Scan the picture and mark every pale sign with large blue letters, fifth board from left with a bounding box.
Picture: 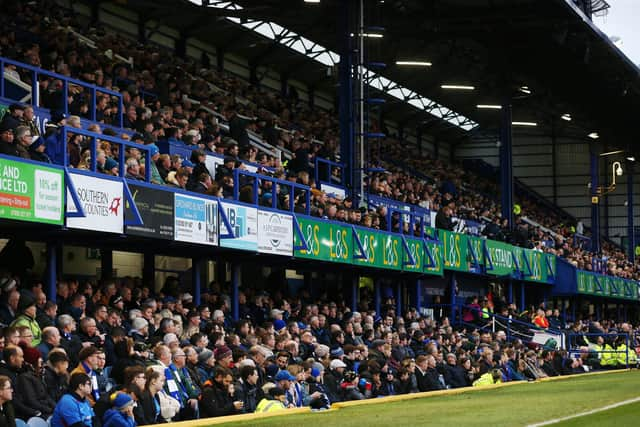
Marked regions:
[220,202,258,252]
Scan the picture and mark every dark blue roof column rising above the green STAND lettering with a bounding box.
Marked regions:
[500,98,513,230]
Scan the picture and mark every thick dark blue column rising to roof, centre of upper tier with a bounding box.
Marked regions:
[338,1,357,189]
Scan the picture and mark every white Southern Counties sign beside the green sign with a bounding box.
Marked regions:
[67,172,124,233]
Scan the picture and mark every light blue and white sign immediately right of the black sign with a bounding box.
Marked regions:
[174,193,218,245]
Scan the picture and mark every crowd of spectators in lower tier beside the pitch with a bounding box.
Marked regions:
[0,274,640,427]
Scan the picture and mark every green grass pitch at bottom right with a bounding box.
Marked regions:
[219,370,640,427]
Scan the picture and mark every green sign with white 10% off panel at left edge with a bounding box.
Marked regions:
[0,159,64,225]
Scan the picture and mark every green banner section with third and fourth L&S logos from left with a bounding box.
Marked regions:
[353,227,403,270]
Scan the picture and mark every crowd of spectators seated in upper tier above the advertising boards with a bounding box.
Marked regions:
[0,0,640,279]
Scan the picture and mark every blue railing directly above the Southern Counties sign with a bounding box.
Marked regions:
[61,126,151,182]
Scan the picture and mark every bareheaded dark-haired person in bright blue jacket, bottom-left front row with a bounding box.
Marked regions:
[51,373,94,427]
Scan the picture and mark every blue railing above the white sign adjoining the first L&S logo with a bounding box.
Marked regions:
[233,169,311,215]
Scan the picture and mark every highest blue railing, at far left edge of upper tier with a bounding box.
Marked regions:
[0,57,123,128]
